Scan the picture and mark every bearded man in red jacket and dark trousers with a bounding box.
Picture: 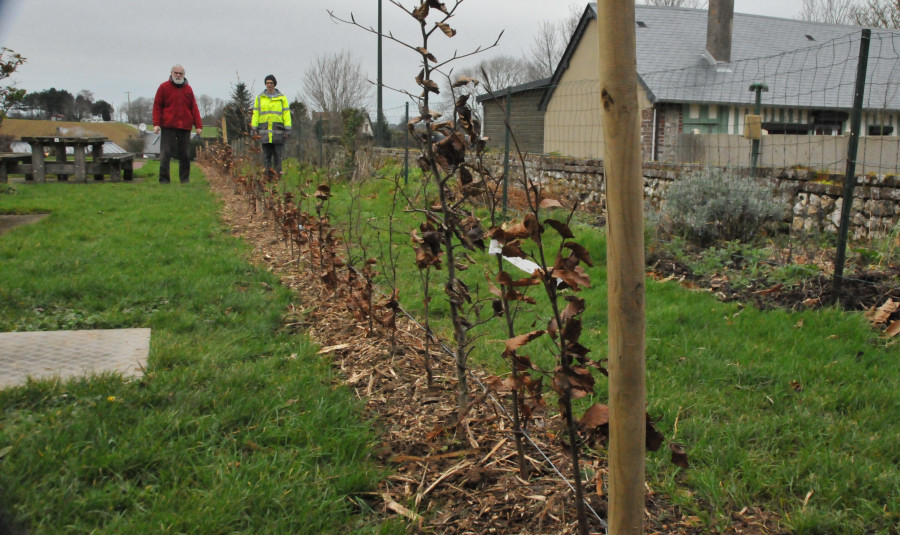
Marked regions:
[153,65,203,184]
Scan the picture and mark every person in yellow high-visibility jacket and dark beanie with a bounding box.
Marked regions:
[250,74,291,173]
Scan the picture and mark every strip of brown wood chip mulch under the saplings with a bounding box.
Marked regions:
[204,166,787,535]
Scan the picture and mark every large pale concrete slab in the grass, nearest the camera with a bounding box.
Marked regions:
[0,329,150,389]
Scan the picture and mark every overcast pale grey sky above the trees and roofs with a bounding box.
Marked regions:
[0,0,802,117]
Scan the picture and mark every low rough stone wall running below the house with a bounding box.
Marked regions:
[375,149,900,241]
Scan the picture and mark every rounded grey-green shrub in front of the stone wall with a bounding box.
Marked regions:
[659,169,785,244]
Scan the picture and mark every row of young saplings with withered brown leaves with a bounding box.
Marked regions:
[205,0,687,533]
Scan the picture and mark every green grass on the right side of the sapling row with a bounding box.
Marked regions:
[296,163,900,534]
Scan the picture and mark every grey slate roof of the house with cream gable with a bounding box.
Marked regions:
[540,3,900,110]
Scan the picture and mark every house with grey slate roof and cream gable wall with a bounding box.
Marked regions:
[524,0,900,160]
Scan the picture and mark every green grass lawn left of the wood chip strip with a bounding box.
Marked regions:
[0,162,402,534]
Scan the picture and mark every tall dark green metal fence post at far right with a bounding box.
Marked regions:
[832,28,872,303]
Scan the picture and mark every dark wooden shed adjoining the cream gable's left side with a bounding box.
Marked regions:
[475,78,550,154]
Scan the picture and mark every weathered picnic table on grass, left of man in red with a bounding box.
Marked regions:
[22,136,108,182]
